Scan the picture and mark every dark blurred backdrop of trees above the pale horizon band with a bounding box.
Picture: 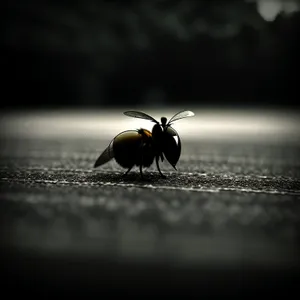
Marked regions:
[2,0,300,107]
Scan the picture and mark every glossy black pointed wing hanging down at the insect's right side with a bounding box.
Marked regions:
[162,127,181,170]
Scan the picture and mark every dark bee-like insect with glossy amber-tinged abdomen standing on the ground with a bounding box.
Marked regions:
[94,110,195,178]
